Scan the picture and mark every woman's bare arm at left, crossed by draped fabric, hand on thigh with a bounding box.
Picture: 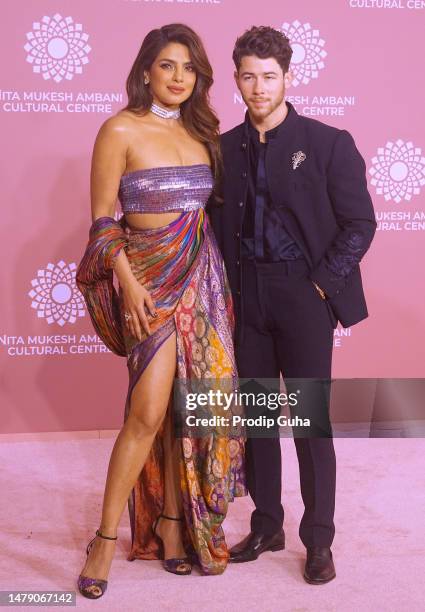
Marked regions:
[90,117,155,340]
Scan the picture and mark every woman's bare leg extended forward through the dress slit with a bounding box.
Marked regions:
[81,332,176,588]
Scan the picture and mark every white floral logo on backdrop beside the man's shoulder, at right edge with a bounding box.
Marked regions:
[369,140,425,204]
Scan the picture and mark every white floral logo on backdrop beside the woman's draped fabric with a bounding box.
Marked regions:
[28,261,86,327]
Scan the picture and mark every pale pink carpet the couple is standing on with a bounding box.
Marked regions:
[0,437,425,612]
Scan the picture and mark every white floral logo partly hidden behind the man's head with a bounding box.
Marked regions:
[280,20,327,87]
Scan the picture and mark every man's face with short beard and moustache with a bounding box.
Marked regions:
[235,55,291,121]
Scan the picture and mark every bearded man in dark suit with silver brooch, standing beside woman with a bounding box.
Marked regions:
[209,27,376,584]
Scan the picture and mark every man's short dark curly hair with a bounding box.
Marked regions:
[232,26,292,74]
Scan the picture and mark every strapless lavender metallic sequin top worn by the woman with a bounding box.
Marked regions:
[118,164,214,214]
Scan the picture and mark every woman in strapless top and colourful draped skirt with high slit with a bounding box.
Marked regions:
[77,24,247,598]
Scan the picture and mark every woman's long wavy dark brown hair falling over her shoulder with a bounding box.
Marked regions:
[124,23,222,194]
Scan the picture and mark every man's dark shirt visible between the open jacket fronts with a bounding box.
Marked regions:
[242,109,303,263]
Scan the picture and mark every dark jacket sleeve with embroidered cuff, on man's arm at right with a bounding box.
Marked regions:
[310,130,376,298]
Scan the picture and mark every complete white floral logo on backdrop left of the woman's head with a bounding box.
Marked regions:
[24,13,91,83]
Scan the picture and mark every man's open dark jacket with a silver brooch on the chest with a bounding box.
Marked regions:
[207,102,376,342]
